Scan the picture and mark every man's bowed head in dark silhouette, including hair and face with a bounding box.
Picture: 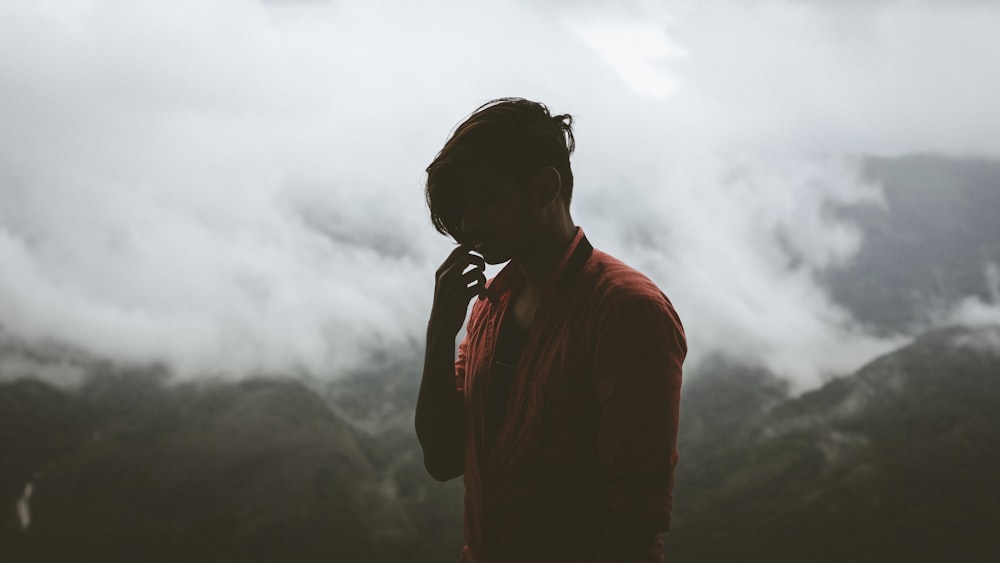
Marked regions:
[426,98,574,260]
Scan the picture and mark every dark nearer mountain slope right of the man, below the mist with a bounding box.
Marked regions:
[667,327,1000,563]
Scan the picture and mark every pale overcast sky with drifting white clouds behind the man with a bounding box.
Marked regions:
[0,0,1000,387]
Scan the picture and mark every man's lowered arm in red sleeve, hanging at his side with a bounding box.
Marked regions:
[595,297,687,563]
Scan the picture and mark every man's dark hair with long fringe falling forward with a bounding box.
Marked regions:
[425,98,576,240]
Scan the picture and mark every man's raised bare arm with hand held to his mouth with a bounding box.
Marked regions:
[414,246,486,481]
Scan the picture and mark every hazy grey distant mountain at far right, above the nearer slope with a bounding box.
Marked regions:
[825,155,1000,333]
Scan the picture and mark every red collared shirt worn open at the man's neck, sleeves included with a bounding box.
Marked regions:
[455,229,687,563]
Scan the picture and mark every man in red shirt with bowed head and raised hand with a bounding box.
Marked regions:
[415,98,687,563]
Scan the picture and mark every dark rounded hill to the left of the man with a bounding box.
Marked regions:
[0,372,461,562]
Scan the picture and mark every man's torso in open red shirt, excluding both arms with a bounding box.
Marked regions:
[464,239,680,561]
